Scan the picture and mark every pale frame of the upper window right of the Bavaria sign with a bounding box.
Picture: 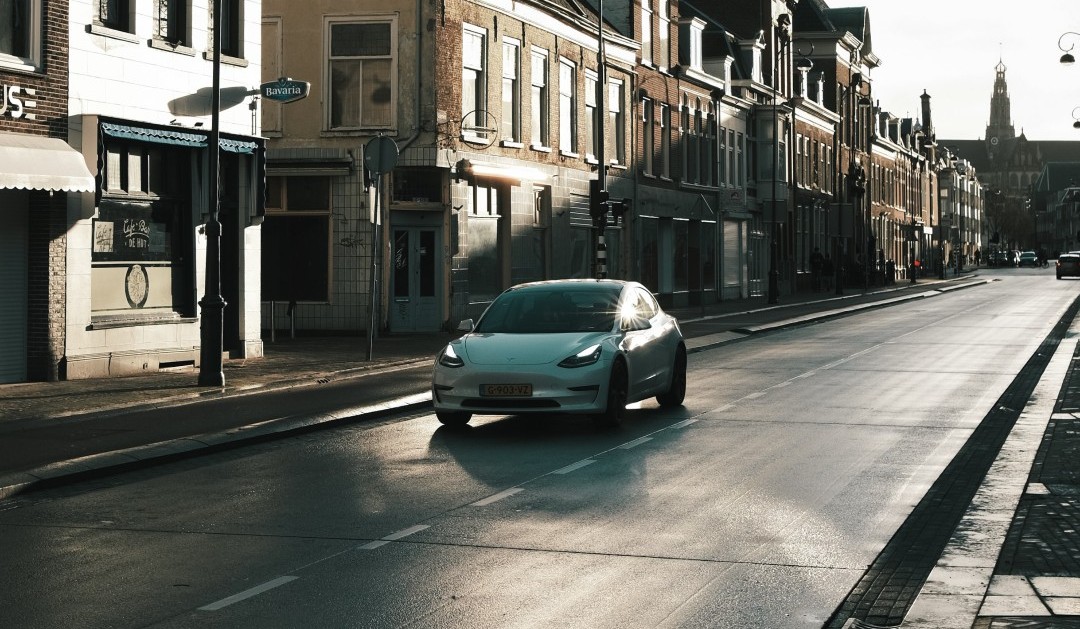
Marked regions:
[323,14,399,133]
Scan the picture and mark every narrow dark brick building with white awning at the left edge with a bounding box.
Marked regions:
[0,0,94,383]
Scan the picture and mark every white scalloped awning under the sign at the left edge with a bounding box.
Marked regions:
[0,132,95,192]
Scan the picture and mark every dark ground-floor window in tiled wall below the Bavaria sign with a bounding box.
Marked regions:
[262,176,333,302]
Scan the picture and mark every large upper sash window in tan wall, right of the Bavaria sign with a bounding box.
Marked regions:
[327,18,396,130]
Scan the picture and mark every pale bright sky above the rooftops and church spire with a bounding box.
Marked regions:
[826,0,1080,140]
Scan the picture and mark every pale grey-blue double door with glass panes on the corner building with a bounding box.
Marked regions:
[390,227,442,332]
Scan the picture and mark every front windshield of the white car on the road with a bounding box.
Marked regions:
[474,285,619,334]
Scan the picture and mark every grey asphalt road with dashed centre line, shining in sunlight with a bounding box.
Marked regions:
[0,271,1075,629]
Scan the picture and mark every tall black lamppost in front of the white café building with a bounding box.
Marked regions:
[199,0,225,387]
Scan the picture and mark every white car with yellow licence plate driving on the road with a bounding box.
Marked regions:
[431,280,686,426]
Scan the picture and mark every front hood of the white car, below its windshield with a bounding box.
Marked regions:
[461,332,608,365]
